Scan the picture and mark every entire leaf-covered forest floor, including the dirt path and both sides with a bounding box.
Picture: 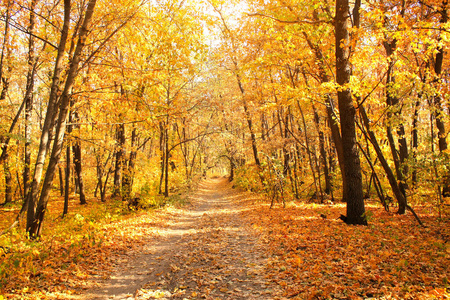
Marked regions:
[0,178,450,300]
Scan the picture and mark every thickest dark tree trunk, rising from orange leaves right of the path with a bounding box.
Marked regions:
[335,0,367,225]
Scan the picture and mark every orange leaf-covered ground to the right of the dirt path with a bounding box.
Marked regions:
[245,199,450,299]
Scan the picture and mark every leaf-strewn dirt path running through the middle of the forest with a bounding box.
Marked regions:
[84,178,282,300]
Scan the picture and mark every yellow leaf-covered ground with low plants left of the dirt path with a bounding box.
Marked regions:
[0,193,174,299]
